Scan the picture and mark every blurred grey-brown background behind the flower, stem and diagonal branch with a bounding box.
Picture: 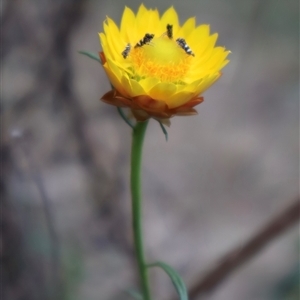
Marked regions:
[0,0,299,300]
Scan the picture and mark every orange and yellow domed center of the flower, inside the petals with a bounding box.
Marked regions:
[130,36,193,83]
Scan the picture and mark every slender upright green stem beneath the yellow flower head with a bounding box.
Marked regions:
[130,121,151,300]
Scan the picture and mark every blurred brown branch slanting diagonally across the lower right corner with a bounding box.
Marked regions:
[189,197,300,299]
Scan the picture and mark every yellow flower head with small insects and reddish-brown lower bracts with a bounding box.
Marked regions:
[99,4,230,121]
